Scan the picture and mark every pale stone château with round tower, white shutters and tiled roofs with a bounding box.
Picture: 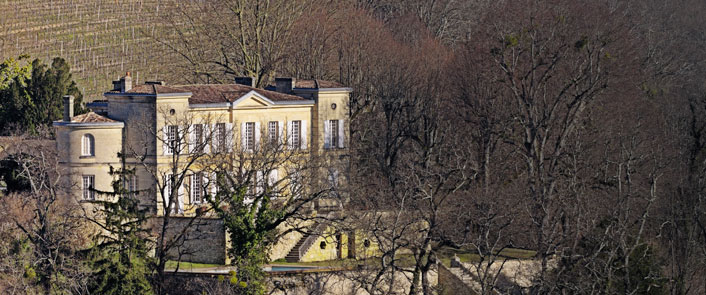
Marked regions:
[54,73,352,262]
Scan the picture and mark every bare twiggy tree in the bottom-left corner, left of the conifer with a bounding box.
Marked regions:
[2,135,90,293]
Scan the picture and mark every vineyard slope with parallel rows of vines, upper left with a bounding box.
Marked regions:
[0,0,182,101]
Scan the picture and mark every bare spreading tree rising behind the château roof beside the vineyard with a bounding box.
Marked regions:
[160,0,312,87]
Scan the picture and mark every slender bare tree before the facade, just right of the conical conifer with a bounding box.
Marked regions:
[125,108,221,293]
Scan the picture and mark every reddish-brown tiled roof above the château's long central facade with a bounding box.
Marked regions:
[109,84,308,104]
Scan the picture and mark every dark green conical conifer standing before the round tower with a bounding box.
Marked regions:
[90,153,152,294]
